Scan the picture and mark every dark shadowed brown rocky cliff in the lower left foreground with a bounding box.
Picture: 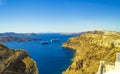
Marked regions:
[0,44,38,74]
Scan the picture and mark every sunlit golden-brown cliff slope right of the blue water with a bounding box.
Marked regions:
[63,31,120,74]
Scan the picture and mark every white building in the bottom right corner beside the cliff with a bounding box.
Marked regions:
[96,53,120,74]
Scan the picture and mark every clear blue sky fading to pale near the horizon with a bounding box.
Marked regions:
[0,0,120,33]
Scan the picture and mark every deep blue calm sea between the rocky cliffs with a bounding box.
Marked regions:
[4,34,75,74]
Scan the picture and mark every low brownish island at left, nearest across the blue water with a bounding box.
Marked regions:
[0,36,39,42]
